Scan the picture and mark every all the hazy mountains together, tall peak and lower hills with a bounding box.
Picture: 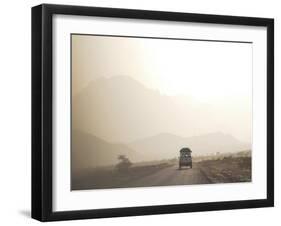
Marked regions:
[72,76,250,168]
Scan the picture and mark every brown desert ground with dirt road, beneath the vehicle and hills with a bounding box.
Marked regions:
[71,152,251,190]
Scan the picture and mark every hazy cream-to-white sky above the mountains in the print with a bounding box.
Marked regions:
[72,35,252,141]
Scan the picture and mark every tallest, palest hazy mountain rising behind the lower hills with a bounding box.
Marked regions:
[72,76,243,143]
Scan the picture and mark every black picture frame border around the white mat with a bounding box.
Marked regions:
[32,4,274,221]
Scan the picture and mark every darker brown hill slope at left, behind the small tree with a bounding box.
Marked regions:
[71,131,141,170]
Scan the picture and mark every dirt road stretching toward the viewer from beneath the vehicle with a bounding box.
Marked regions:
[126,164,210,187]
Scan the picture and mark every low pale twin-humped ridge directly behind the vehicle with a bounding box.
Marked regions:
[128,132,248,159]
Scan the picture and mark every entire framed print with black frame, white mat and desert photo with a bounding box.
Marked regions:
[32,4,274,221]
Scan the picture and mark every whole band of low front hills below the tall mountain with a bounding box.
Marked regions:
[71,131,248,169]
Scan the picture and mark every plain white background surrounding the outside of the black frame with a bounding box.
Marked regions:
[0,0,276,226]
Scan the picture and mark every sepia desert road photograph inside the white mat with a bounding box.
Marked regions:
[70,33,253,191]
